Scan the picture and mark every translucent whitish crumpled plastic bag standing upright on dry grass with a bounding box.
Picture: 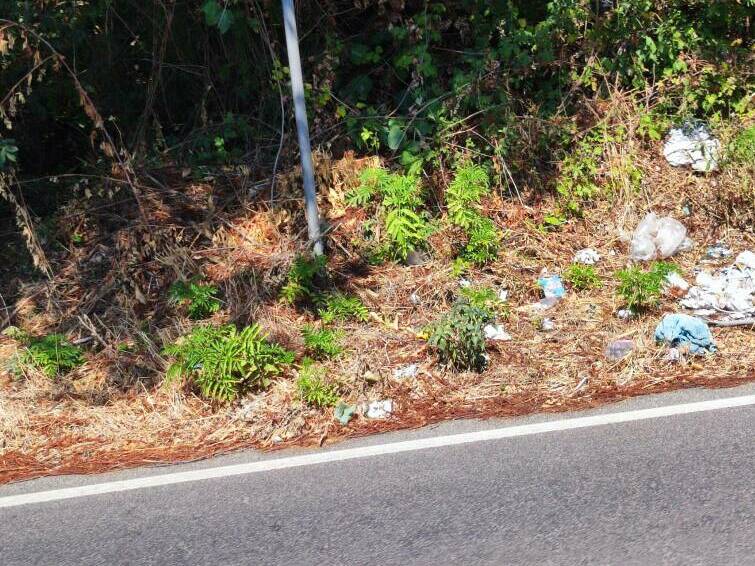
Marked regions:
[629,212,693,261]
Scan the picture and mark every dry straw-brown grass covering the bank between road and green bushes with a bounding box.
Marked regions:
[0,120,755,482]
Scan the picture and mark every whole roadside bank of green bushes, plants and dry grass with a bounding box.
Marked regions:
[0,0,755,481]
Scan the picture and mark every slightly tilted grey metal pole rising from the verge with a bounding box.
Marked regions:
[281,0,322,255]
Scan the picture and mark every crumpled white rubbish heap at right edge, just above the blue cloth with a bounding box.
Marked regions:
[680,255,755,326]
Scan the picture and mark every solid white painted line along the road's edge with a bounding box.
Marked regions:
[0,395,755,508]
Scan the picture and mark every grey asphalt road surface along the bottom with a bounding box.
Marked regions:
[0,387,755,566]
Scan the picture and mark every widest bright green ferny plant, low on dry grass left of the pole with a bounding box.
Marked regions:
[164,324,294,401]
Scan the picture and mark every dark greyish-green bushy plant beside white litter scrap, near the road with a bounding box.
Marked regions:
[428,301,493,371]
